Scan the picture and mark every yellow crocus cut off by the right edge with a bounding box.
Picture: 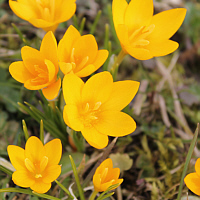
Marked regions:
[184,158,200,196]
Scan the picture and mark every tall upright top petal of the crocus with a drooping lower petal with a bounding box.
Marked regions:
[40,31,58,73]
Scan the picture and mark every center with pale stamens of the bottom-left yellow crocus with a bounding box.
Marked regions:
[24,156,48,179]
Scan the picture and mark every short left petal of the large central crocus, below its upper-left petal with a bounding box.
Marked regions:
[63,105,84,131]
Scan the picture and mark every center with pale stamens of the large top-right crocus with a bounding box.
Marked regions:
[129,24,155,48]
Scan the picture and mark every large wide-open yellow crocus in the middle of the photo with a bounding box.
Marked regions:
[63,72,139,149]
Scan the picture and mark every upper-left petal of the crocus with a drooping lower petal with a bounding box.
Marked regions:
[21,46,45,76]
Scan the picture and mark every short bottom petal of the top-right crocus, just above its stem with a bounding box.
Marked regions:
[125,46,153,60]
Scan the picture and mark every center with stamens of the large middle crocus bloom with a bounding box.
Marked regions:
[81,101,101,127]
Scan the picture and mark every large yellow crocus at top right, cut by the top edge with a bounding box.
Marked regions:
[112,0,186,60]
